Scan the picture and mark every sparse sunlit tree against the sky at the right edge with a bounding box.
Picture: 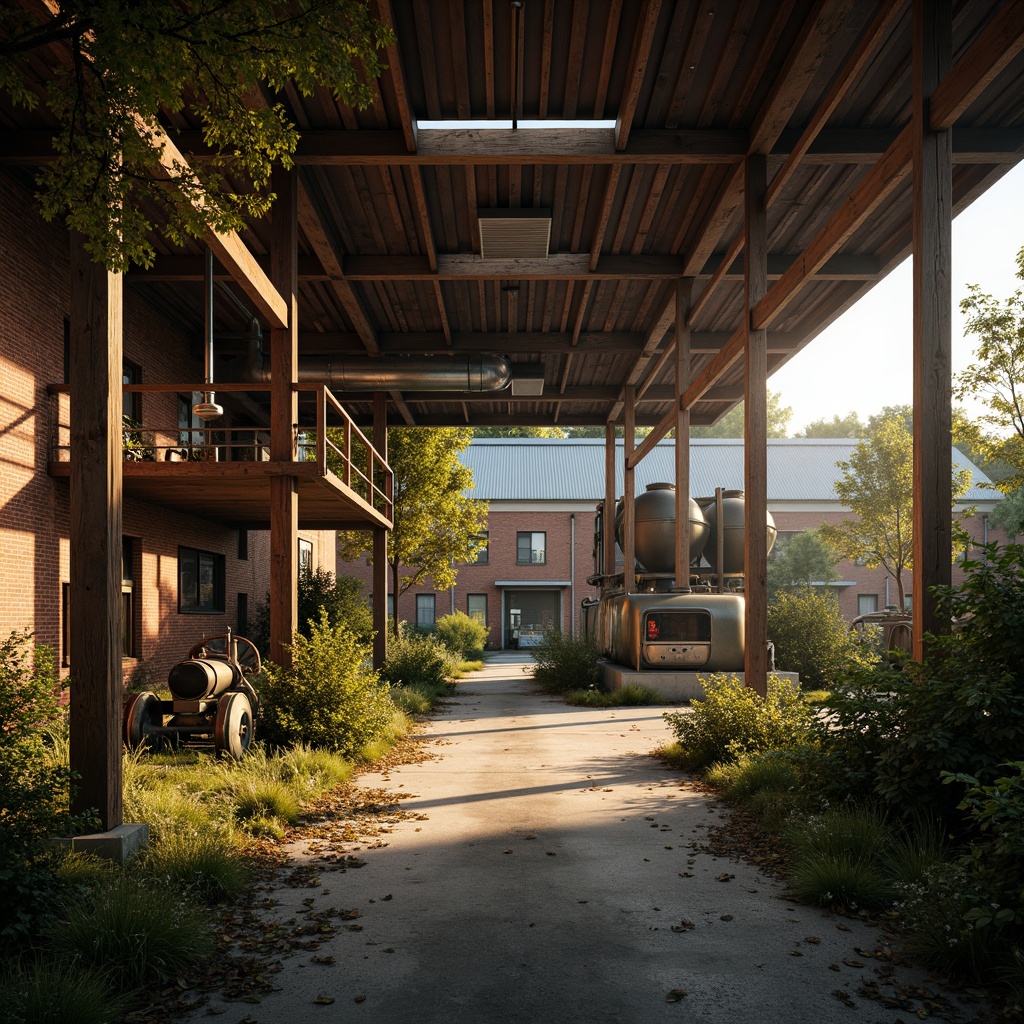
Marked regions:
[953,249,1024,494]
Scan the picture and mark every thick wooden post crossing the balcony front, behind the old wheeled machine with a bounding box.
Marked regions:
[270,170,299,668]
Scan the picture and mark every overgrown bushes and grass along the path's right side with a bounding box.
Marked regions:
[666,546,1024,1002]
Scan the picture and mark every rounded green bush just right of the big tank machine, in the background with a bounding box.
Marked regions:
[768,587,879,688]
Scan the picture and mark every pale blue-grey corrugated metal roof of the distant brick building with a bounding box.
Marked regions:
[462,437,998,503]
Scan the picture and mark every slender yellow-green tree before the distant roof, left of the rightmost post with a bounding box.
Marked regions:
[819,416,970,608]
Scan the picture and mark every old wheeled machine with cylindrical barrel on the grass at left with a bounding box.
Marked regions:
[122,630,260,760]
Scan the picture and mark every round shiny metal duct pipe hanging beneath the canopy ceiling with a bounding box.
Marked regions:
[243,339,512,392]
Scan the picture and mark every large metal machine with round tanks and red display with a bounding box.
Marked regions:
[582,483,776,672]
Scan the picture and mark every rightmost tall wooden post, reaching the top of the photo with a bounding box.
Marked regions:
[912,0,952,660]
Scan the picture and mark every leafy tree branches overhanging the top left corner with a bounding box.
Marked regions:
[0,0,393,270]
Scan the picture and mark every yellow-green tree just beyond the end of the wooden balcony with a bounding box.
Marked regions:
[338,427,487,635]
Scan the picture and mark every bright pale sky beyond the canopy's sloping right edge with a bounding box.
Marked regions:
[768,157,1024,434]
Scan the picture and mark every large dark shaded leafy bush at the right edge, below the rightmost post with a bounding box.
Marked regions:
[818,545,1024,827]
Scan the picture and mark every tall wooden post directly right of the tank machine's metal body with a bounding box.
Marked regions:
[743,154,768,696]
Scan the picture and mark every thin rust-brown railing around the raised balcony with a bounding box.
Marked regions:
[47,383,394,520]
